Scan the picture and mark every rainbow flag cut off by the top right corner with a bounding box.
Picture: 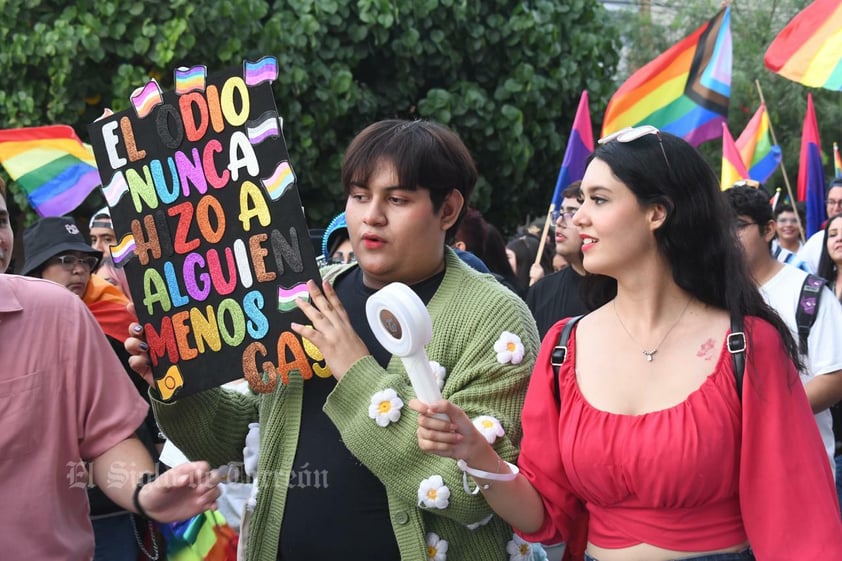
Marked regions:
[763,0,842,91]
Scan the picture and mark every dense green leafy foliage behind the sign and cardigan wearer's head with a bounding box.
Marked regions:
[0,0,620,236]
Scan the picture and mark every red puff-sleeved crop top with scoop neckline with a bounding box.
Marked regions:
[518,317,842,561]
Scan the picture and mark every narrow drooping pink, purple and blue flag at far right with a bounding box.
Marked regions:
[798,93,827,237]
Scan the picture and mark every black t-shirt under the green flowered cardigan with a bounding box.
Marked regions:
[278,267,444,561]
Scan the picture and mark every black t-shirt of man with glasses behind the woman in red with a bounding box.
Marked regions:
[526,267,588,339]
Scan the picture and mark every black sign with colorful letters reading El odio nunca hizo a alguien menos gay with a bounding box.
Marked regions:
[89,57,330,401]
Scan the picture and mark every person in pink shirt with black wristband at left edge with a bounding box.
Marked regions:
[0,181,219,561]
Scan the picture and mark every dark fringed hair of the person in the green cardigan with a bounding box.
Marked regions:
[342,119,477,239]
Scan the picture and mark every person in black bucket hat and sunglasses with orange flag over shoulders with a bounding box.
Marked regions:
[21,216,169,561]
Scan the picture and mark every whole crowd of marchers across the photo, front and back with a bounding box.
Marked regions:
[0,120,842,561]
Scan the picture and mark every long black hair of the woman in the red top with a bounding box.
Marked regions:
[583,132,803,370]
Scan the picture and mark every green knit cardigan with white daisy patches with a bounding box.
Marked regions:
[150,249,539,561]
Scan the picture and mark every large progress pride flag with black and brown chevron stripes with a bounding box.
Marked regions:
[602,7,731,146]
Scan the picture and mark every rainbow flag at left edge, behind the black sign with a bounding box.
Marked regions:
[0,125,100,216]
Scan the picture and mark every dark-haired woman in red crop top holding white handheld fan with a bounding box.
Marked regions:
[410,126,842,561]
